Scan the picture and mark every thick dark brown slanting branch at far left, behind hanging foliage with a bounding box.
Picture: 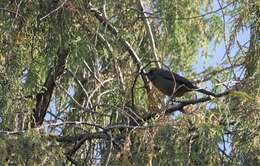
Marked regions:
[32,49,68,127]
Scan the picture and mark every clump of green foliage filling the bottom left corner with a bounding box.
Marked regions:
[0,131,64,165]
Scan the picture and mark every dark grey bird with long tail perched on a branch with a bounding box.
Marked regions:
[144,68,216,97]
